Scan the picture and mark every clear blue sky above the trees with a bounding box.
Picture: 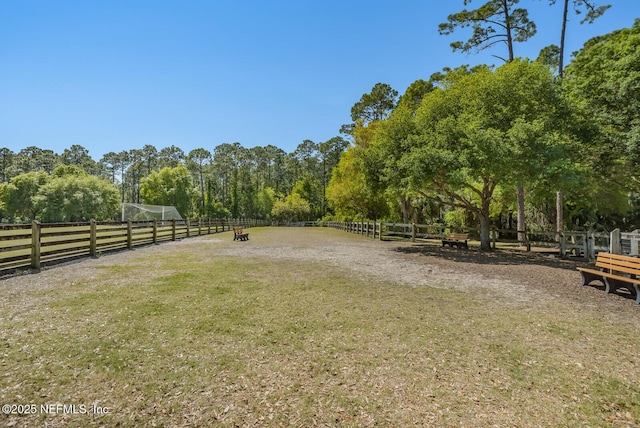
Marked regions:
[0,0,640,160]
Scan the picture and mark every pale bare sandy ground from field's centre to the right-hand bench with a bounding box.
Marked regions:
[221,228,640,317]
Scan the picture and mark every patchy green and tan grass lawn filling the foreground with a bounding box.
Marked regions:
[0,229,640,427]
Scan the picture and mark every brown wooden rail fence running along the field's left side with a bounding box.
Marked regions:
[0,219,266,273]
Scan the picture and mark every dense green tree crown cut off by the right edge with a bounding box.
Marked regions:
[563,22,640,186]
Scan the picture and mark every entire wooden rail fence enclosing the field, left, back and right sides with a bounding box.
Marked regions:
[0,219,640,274]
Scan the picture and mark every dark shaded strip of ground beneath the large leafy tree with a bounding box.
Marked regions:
[394,243,587,271]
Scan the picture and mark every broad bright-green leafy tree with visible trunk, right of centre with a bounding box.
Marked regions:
[396,60,564,249]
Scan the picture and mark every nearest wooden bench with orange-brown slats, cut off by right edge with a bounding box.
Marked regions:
[577,253,640,305]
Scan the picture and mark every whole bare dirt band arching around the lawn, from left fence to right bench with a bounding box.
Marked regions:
[0,228,640,324]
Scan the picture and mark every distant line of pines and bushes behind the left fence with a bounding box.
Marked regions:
[0,136,348,223]
